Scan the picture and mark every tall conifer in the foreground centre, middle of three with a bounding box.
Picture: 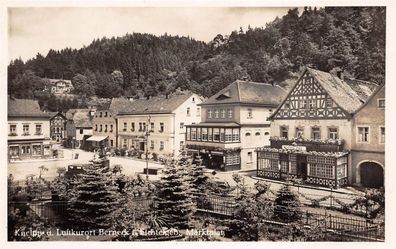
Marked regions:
[155,155,194,229]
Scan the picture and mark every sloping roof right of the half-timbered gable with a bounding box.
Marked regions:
[303,67,365,114]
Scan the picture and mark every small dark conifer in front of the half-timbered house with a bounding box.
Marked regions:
[274,184,302,223]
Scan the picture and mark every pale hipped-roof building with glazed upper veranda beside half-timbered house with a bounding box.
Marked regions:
[186,80,286,170]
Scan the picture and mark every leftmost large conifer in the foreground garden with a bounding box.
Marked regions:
[69,159,118,229]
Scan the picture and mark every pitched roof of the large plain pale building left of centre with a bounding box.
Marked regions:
[119,93,193,115]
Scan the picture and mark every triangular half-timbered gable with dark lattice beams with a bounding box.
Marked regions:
[271,70,350,119]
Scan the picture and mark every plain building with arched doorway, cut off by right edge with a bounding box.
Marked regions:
[351,85,385,187]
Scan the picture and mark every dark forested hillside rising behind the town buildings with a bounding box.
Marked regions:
[8,7,386,103]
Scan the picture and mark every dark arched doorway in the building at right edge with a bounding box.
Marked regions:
[360,162,384,188]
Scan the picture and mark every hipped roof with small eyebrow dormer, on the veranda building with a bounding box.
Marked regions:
[200,80,286,106]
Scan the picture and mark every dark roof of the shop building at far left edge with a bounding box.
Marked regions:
[8,98,50,119]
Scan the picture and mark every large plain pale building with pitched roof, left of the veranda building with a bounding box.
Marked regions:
[117,93,202,158]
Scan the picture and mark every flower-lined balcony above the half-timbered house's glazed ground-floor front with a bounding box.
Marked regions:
[270,137,344,152]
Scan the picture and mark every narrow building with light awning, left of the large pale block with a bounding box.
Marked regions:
[87,98,131,147]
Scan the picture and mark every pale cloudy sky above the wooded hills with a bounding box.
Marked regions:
[8,7,289,61]
